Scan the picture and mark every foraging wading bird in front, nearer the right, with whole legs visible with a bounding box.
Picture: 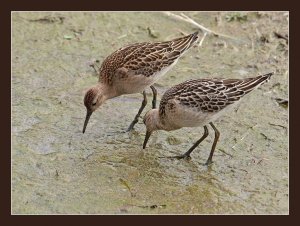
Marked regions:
[143,72,273,165]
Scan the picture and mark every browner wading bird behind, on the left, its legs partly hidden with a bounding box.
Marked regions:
[82,32,199,133]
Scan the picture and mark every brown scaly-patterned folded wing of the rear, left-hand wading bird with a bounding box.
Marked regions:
[99,32,199,83]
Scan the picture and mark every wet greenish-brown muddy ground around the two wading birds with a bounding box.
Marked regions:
[11,12,289,214]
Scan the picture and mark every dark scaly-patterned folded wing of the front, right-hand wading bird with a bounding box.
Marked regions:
[161,73,273,113]
